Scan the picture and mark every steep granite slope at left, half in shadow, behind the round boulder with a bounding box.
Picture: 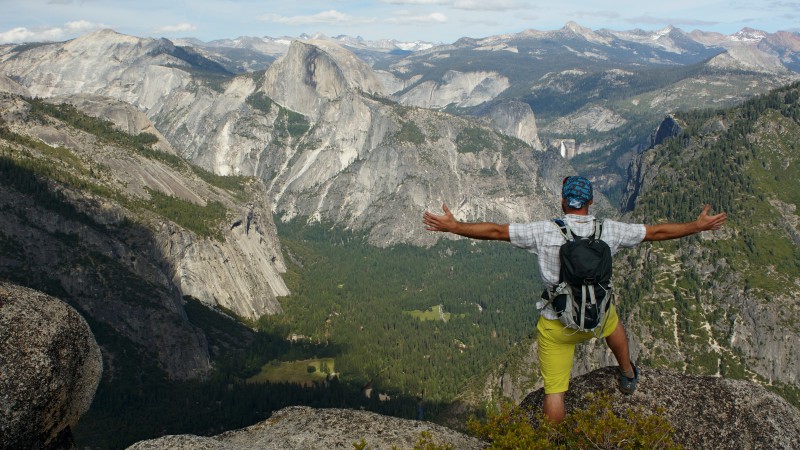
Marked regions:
[0,94,288,378]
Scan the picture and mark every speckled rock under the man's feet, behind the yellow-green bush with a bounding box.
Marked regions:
[522,367,800,449]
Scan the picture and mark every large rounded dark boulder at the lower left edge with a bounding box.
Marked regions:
[0,283,103,449]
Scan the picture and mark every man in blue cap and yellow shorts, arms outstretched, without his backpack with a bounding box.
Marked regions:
[422,176,726,423]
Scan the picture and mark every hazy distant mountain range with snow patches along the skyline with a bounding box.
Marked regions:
[173,22,800,72]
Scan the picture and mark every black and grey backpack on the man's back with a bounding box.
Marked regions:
[545,219,612,334]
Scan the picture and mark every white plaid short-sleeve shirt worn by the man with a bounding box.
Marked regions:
[508,214,645,319]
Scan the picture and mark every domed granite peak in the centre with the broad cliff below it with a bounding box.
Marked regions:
[256,39,567,245]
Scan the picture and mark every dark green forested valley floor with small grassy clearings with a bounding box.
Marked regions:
[75,221,539,448]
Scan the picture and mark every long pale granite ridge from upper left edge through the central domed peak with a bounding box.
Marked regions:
[0,31,570,245]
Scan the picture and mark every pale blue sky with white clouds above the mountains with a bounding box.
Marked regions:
[0,0,800,43]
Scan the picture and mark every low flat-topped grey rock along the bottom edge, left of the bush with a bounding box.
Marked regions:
[128,406,487,450]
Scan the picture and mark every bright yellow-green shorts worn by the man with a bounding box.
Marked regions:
[536,305,619,394]
